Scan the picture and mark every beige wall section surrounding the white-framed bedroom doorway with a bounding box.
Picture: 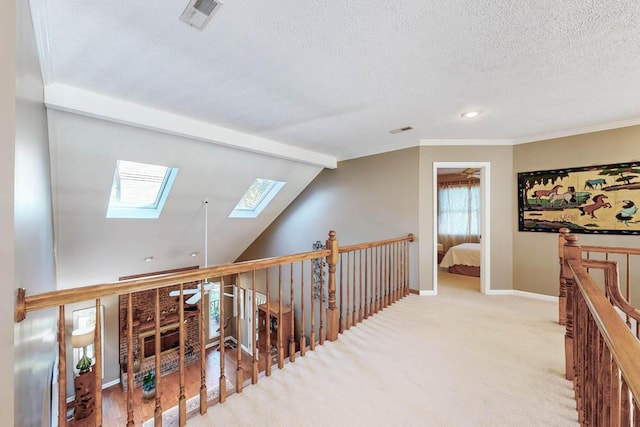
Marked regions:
[418,146,516,290]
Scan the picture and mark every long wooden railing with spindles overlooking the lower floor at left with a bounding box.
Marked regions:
[16,231,414,426]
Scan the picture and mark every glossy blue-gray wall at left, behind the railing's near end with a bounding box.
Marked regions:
[12,1,57,426]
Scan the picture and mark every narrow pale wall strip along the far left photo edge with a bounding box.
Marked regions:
[0,0,16,426]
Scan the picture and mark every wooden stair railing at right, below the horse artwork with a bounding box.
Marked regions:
[560,233,640,426]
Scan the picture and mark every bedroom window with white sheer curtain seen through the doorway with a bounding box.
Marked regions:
[438,182,480,251]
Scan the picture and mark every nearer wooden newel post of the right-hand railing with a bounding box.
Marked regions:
[561,234,582,380]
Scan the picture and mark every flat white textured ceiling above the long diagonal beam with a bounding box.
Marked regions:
[38,0,640,159]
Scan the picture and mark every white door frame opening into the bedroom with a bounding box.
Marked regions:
[433,162,491,295]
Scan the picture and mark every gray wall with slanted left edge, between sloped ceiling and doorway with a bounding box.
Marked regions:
[239,148,419,289]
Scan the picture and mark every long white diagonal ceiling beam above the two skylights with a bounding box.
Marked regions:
[44,83,338,169]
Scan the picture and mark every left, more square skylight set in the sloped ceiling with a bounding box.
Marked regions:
[107,160,178,218]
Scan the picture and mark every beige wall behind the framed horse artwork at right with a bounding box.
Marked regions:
[511,126,640,296]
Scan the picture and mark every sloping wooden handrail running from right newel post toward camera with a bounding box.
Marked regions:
[568,260,640,399]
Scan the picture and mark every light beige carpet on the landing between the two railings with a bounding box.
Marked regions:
[188,274,577,427]
